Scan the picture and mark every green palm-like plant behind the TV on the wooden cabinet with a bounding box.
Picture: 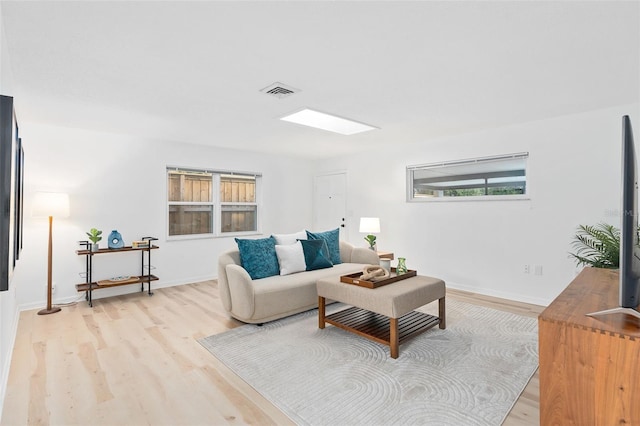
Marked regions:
[569,223,620,269]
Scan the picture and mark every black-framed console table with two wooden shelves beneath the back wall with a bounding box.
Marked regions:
[76,237,160,306]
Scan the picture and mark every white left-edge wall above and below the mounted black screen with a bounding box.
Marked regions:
[0,5,18,418]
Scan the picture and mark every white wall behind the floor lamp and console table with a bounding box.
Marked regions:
[15,123,312,309]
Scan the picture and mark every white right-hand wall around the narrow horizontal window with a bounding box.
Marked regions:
[316,104,640,305]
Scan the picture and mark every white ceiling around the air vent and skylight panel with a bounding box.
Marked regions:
[0,0,640,158]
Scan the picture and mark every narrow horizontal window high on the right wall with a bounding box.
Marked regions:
[407,153,529,201]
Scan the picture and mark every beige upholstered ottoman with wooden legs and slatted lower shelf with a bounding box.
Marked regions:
[316,276,446,358]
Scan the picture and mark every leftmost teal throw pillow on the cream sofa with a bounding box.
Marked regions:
[236,237,280,280]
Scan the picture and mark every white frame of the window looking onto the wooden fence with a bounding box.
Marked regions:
[165,166,262,241]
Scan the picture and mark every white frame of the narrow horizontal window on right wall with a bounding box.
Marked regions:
[406,152,530,203]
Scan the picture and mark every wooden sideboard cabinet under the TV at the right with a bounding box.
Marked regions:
[538,268,640,426]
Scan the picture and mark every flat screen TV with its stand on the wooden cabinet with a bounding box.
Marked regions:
[588,115,640,318]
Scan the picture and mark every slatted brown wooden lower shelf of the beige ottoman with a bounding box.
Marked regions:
[321,307,440,358]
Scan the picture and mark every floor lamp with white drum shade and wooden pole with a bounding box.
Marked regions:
[31,192,69,315]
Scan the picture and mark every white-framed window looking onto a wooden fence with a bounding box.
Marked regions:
[167,167,260,237]
